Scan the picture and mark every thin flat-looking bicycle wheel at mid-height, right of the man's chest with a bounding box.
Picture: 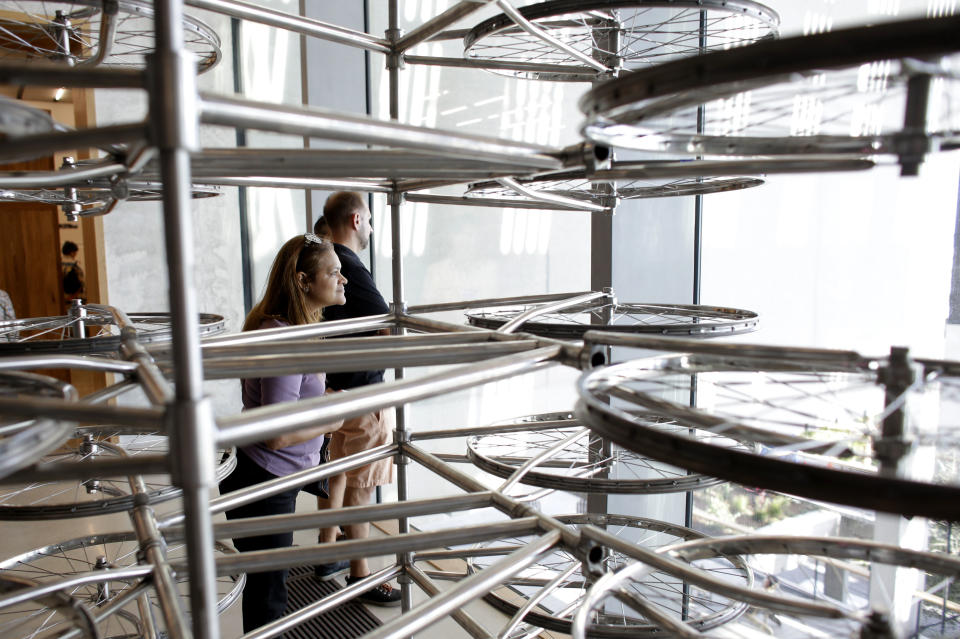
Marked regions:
[467,298,760,339]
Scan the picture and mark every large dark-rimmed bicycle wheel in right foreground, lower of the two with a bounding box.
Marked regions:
[576,337,960,520]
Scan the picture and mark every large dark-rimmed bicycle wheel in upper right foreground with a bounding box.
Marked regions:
[580,16,960,163]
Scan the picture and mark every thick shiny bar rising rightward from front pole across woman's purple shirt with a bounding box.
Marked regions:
[218,346,563,446]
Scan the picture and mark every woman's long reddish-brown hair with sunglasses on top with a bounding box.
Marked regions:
[243,235,333,331]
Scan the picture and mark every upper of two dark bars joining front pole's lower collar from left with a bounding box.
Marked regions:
[0,397,166,430]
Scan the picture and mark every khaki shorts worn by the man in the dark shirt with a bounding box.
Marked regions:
[330,408,396,487]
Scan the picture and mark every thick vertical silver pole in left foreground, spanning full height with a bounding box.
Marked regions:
[150,0,220,639]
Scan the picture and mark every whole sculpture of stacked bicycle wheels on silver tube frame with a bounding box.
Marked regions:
[0,0,960,639]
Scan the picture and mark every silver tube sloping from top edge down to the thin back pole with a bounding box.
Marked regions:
[184,0,390,53]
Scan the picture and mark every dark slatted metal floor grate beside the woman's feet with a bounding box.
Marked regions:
[283,566,380,639]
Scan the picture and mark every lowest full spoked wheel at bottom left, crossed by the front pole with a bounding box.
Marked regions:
[0,532,245,639]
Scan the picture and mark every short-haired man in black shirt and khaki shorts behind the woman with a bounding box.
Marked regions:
[314,191,400,606]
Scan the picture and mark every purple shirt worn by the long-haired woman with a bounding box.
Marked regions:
[240,319,326,477]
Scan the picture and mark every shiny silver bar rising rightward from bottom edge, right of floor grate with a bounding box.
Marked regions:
[366,520,560,639]
